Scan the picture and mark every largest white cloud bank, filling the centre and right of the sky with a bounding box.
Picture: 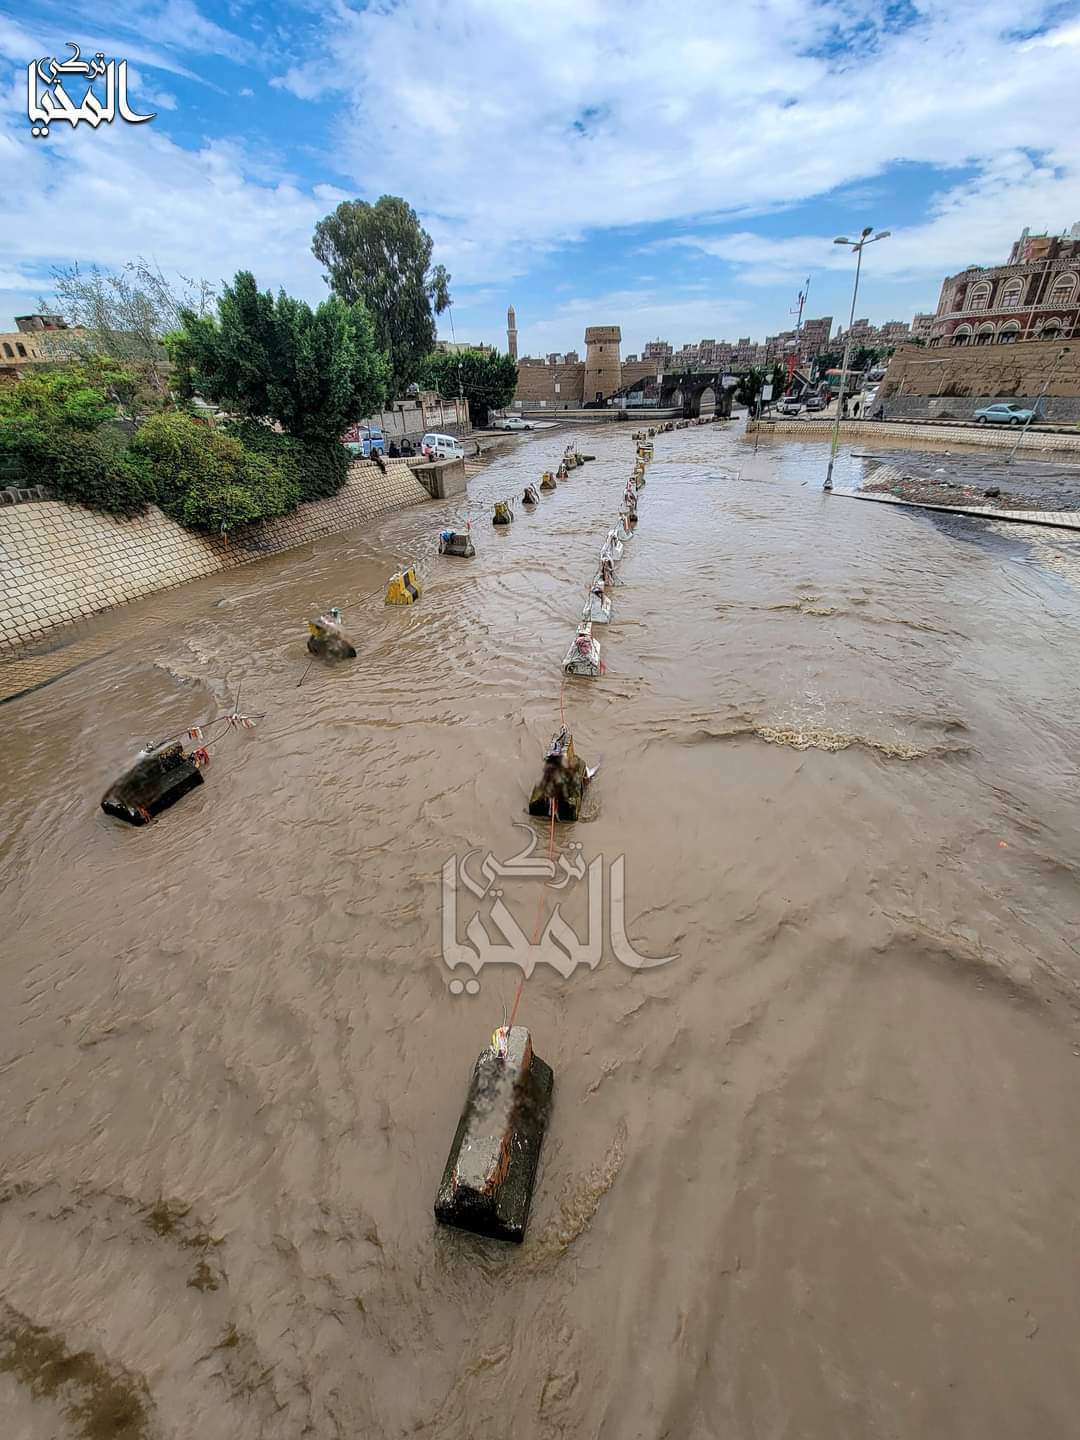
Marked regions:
[264,0,1080,279]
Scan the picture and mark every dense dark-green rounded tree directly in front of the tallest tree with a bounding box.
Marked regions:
[167,271,387,444]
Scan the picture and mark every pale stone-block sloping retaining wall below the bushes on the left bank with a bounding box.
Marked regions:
[0,459,429,654]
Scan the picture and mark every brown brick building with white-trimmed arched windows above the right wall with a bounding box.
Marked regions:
[929,223,1080,347]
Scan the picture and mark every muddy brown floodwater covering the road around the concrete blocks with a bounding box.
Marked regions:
[0,426,1080,1440]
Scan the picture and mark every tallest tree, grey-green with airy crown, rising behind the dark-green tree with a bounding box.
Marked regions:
[311,194,449,395]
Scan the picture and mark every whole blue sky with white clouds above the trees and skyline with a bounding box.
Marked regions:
[0,0,1080,354]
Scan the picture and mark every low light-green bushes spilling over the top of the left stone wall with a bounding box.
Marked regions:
[0,363,348,534]
